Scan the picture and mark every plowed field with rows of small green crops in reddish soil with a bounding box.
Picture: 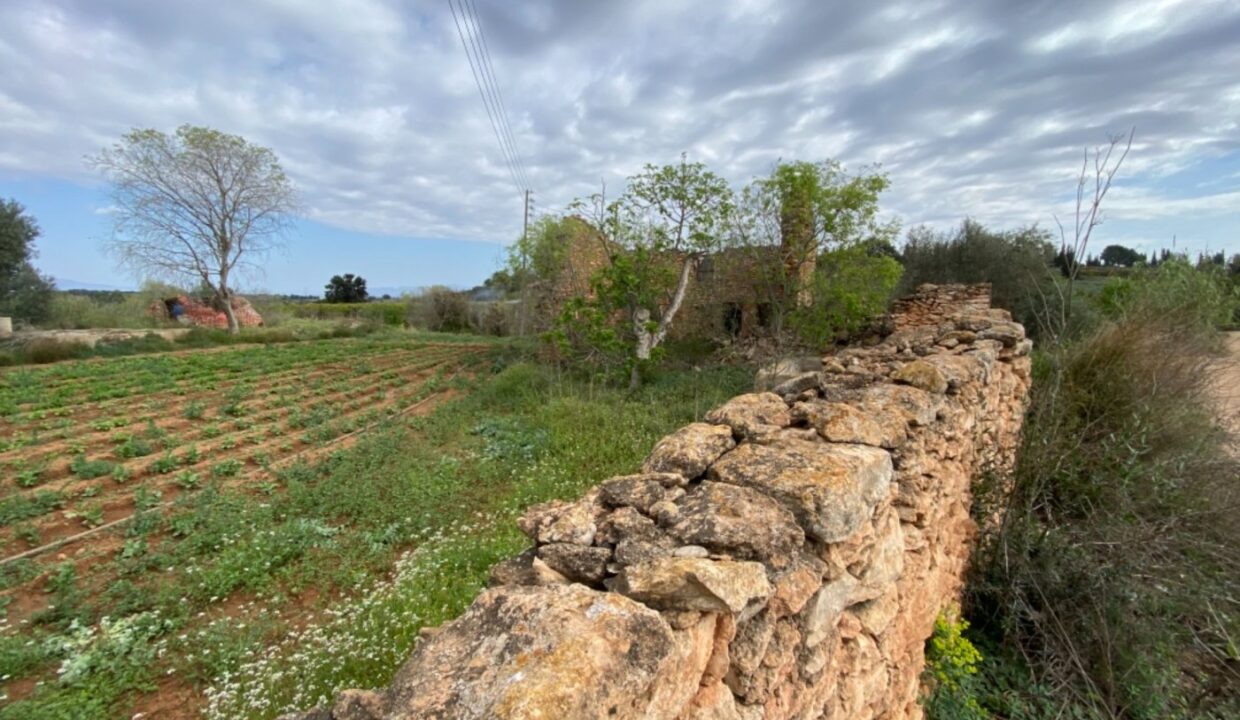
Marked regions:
[0,337,482,612]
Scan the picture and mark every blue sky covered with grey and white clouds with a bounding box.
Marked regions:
[0,0,1240,292]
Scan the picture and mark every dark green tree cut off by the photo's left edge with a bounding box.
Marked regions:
[0,194,53,322]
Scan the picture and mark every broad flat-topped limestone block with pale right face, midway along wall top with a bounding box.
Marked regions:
[711,441,893,543]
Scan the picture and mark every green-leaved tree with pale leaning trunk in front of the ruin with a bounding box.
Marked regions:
[559,156,733,387]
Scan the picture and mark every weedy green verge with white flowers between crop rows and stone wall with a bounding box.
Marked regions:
[0,356,749,720]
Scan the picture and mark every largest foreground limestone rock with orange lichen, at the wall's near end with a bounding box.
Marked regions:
[384,585,677,720]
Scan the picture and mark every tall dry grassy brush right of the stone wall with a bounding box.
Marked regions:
[968,261,1240,720]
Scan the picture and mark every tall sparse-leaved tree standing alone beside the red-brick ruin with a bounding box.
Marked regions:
[87,125,295,333]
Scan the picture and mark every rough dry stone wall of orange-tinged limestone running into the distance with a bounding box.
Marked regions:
[285,286,1030,720]
